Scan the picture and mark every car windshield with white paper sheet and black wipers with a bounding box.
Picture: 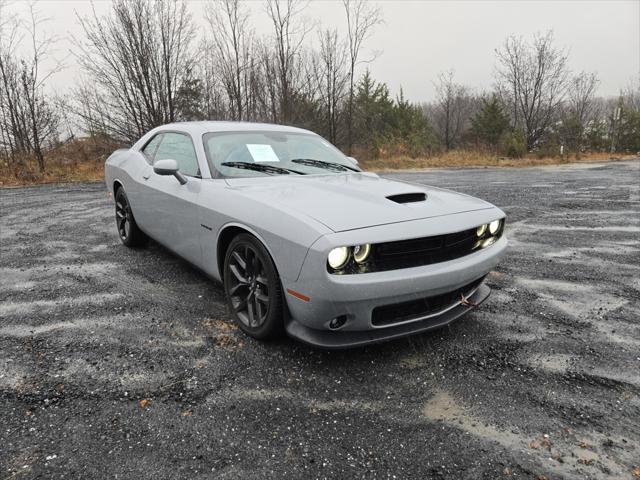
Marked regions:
[204,131,360,177]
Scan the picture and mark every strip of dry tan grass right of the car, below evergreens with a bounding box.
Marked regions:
[360,150,636,172]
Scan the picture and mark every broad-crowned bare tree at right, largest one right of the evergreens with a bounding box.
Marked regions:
[496,31,568,149]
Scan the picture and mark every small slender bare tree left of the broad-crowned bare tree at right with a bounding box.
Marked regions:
[432,70,472,150]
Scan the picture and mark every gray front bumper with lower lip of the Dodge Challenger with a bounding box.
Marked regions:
[284,229,507,348]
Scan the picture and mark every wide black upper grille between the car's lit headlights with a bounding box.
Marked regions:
[371,228,478,271]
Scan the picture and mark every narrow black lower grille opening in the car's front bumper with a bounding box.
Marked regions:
[371,277,484,327]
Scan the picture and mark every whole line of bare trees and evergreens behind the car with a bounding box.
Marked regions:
[0,0,640,171]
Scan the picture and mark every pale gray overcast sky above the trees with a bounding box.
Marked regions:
[14,0,640,102]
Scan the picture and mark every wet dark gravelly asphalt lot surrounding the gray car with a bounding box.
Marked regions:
[0,161,640,480]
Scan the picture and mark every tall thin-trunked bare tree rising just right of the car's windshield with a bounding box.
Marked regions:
[342,0,382,154]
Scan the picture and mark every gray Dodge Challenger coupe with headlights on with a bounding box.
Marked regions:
[105,122,507,348]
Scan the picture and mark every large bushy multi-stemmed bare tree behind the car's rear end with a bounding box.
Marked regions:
[76,0,194,141]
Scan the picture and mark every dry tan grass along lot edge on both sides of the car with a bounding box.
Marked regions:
[0,139,634,187]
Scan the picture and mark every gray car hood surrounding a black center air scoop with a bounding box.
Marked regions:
[226,173,494,232]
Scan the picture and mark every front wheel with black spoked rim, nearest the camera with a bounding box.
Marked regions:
[224,234,284,340]
